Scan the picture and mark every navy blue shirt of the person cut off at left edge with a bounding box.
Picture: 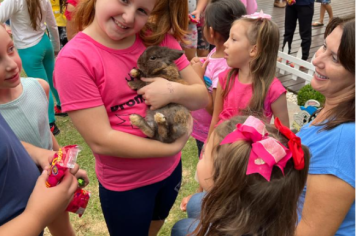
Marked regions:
[0,113,40,225]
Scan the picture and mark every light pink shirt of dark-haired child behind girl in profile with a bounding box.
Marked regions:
[192,48,229,142]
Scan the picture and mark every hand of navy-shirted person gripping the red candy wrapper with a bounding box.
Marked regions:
[24,171,78,227]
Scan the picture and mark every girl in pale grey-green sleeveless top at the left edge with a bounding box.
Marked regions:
[0,23,88,236]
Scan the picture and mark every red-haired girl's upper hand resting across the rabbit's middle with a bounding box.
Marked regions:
[137,77,176,110]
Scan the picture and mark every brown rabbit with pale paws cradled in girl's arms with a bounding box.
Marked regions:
[128,46,191,143]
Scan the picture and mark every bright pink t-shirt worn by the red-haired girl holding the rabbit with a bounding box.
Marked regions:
[53,32,189,191]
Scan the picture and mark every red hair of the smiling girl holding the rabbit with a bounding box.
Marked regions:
[74,0,188,46]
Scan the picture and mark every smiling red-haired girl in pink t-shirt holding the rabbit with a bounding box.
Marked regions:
[54,0,208,235]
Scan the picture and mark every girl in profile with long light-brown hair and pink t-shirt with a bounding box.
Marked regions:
[209,12,289,136]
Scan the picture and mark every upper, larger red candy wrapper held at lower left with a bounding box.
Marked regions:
[46,145,80,188]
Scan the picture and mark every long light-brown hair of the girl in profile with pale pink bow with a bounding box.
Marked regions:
[223,18,279,113]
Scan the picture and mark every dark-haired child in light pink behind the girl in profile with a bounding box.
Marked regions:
[191,0,246,157]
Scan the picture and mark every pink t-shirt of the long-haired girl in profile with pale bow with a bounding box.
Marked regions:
[218,70,286,124]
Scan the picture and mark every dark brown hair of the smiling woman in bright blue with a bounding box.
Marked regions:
[319,15,355,130]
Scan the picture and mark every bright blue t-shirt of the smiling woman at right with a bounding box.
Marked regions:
[297,123,355,236]
